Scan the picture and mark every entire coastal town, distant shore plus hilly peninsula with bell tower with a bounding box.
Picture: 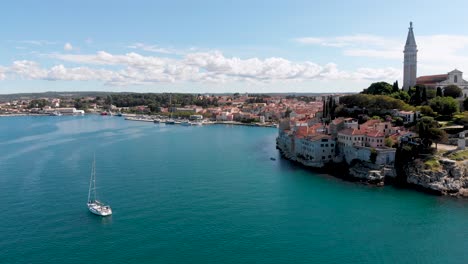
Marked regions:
[0,23,468,195]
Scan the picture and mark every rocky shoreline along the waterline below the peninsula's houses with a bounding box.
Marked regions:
[278,144,468,197]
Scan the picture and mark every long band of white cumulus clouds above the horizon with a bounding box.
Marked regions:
[1,51,399,85]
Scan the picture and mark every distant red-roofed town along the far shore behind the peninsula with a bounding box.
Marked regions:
[0,94,342,126]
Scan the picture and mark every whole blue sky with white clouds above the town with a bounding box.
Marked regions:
[0,1,468,93]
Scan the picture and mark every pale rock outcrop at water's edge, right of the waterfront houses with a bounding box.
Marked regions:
[404,158,468,196]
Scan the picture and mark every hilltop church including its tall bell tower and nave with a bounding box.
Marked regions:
[403,22,468,97]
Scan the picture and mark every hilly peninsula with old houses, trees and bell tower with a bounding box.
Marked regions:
[277,23,468,196]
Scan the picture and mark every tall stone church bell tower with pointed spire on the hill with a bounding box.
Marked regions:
[403,22,418,91]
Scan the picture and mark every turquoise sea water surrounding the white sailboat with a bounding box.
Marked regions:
[0,116,468,263]
